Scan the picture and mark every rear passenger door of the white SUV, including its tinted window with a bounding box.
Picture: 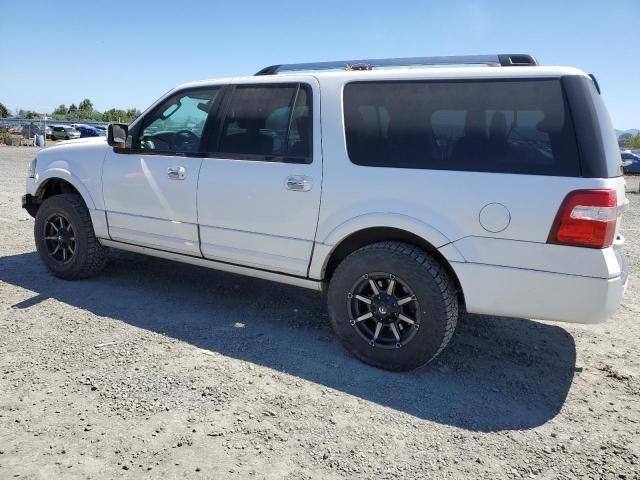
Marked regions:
[198,77,322,276]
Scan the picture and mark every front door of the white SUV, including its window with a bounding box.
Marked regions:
[102,87,219,256]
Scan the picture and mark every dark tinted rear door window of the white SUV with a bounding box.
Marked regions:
[219,85,312,160]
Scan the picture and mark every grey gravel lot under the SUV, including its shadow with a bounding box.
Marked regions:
[0,147,640,479]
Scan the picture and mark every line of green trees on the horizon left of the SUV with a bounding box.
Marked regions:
[0,98,140,123]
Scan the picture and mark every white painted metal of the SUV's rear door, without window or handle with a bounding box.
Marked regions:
[198,76,322,276]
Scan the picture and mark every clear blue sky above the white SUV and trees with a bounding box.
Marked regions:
[0,0,640,129]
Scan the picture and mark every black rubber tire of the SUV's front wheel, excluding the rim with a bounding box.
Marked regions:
[33,193,107,280]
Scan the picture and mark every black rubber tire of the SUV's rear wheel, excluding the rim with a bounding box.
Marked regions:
[327,241,458,371]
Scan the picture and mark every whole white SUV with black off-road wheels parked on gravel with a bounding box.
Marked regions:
[23,55,627,370]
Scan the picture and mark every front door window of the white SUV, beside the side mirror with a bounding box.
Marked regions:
[136,87,219,153]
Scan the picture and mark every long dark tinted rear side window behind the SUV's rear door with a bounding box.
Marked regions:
[344,80,580,176]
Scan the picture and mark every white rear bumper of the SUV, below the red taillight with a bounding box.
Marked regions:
[452,254,629,323]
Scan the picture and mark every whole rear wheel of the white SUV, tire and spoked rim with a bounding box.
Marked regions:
[328,242,458,371]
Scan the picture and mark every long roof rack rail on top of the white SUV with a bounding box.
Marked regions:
[256,54,538,75]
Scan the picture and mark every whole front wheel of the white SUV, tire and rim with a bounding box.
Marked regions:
[34,194,107,280]
